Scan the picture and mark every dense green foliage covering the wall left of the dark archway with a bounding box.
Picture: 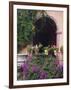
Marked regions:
[17,9,36,51]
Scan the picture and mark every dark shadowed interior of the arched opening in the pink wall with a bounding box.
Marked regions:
[33,16,57,46]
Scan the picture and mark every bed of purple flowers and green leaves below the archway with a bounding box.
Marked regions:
[17,54,63,80]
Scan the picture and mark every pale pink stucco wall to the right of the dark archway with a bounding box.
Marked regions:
[47,11,63,47]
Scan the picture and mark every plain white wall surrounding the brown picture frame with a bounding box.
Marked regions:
[0,0,71,90]
